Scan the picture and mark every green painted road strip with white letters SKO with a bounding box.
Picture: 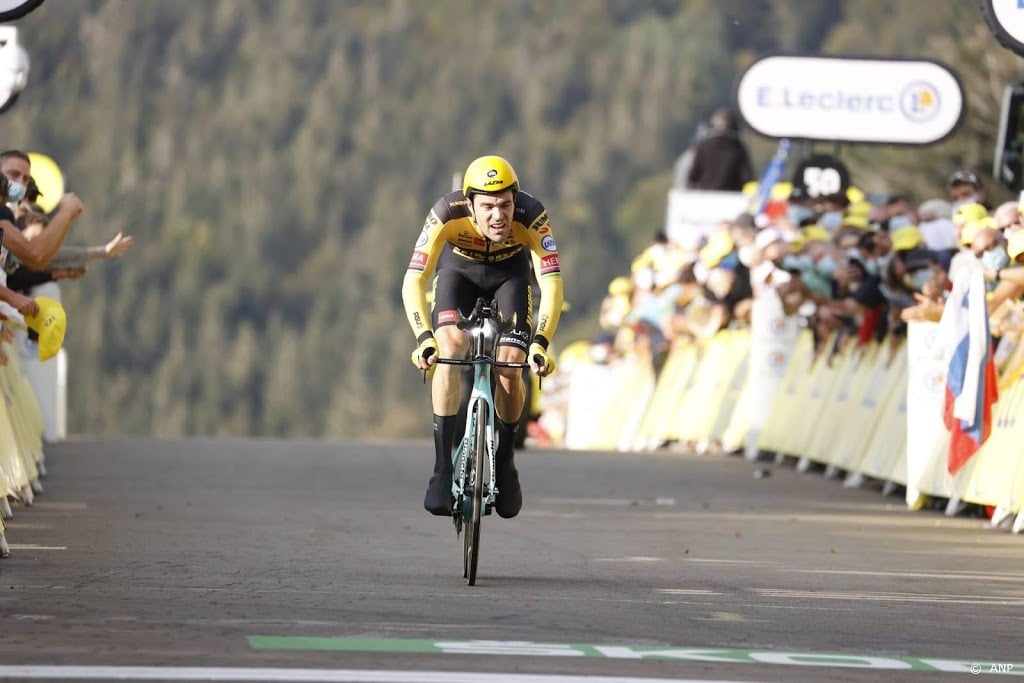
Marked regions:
[247,636,1024,676]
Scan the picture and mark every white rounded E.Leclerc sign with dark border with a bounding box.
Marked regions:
[736,55,964,144]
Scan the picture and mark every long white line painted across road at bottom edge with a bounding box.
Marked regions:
[0,665,750,683]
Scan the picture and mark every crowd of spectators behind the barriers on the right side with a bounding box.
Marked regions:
[585,171,1024,376]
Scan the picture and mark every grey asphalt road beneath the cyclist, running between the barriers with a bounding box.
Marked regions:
[0,438,1024,683]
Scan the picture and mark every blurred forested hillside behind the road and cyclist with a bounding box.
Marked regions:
[0,0,1024,438]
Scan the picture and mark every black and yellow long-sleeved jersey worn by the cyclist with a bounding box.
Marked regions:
[401,190,562,347]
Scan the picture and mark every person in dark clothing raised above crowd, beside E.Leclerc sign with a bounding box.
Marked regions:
[686,108,754,191]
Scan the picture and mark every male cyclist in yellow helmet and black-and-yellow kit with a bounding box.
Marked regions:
[401,156,562,518]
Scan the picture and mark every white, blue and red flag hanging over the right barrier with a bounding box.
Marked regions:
[939,267,998,474]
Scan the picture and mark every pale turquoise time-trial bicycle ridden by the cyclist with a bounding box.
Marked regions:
[428,297,529,586]
